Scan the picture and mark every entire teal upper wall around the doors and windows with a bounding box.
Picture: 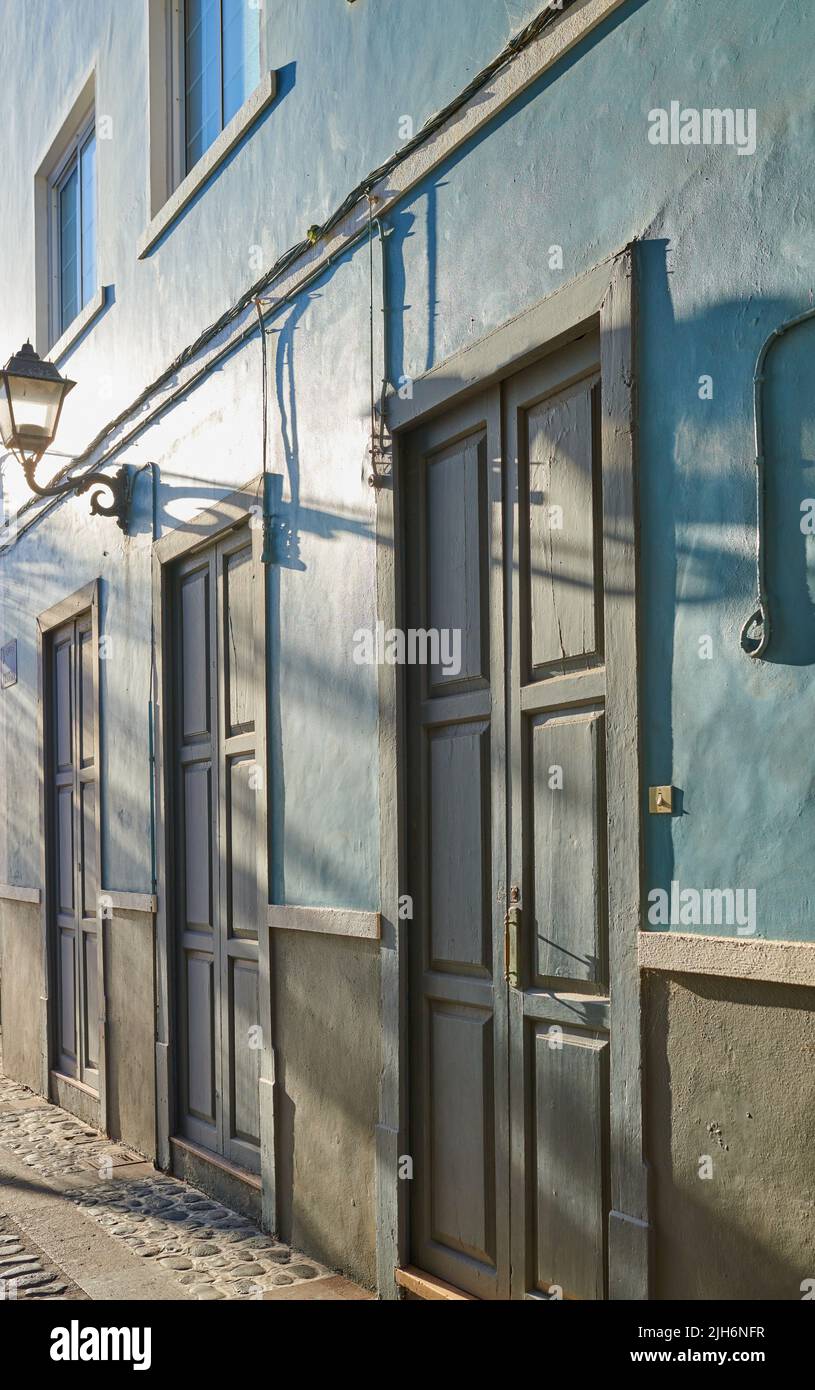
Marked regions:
[0,0,815,940]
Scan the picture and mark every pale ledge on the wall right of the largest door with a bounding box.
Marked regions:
[638,931,815,988]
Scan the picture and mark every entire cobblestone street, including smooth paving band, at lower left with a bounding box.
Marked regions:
[0,1076,373,1300]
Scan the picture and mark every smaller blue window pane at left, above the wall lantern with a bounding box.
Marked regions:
[49,115,97,342]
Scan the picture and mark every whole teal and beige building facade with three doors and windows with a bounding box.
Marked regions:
[0,0,815,1300]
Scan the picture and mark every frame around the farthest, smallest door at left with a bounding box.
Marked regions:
[36,580,107,1133]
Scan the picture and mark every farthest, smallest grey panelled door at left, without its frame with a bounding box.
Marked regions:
[46,612,102,1091]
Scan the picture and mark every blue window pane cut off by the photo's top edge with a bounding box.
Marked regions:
[184,0,261,172]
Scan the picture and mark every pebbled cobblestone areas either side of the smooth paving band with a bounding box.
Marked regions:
[0,1074,346,1300]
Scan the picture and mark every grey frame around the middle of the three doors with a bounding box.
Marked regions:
[153,475,277,1230]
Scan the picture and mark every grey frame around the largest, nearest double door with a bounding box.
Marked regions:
[377,245,651,1300]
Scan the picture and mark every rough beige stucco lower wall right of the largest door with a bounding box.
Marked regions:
[645,976,815,1300]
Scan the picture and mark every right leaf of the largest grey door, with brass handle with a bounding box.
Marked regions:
[503,334,615,1298]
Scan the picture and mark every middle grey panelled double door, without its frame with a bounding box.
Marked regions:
[171,527,264,1172]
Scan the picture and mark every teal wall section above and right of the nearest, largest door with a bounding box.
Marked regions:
[392,0,815,940]
